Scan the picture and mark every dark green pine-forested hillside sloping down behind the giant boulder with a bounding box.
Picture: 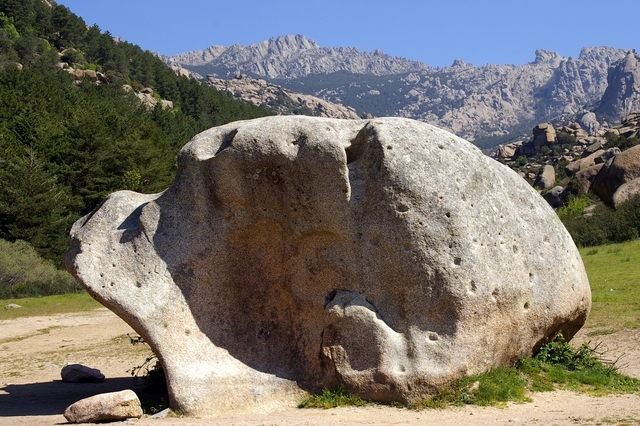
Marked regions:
[0,0,270,282]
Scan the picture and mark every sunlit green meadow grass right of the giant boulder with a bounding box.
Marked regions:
[580,240,640,332]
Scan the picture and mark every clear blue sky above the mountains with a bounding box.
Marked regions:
[58,0,640,67]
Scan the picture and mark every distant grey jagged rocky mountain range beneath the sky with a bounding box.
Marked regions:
[159,35,640,145]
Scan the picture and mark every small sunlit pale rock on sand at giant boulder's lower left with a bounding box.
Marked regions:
[64,389,143,423]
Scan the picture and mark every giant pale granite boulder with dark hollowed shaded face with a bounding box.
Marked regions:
[65,117,591,416]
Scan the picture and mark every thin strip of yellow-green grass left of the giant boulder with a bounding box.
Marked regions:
[0,292,102,320]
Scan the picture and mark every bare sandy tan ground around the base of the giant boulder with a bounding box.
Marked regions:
[0,309,640,426]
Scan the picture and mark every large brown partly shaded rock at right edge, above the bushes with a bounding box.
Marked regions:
[593,145,640,207]
